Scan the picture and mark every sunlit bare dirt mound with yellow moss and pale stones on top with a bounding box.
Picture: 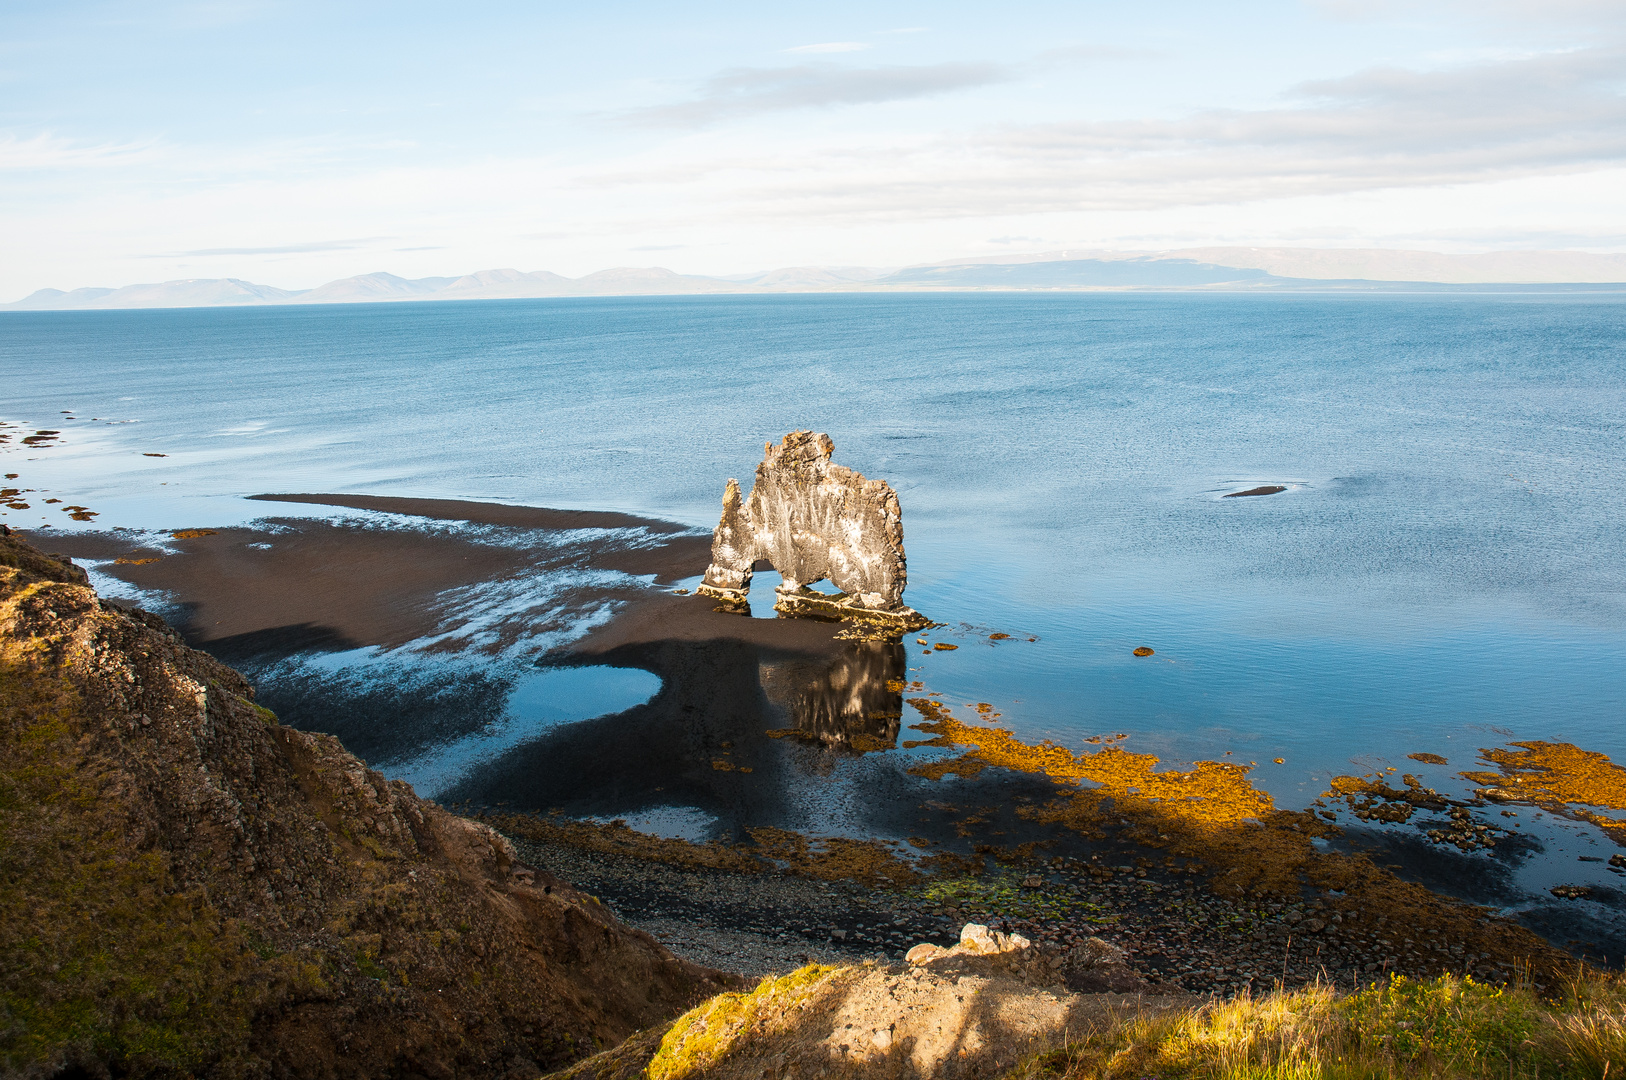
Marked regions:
[553,925,1195,1080]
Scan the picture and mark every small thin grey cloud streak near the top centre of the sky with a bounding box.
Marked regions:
[623,63,1013,127]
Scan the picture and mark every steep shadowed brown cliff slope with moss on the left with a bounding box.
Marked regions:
[0,535,727,1078]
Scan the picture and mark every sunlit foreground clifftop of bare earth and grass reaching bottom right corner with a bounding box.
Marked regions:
[554,968,1626,1080]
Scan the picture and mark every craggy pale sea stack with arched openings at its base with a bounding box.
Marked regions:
[699,431,930,631]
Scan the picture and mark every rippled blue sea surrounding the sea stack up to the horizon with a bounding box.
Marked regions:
[0,293,1626,880]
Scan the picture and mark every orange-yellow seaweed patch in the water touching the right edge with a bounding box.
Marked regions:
[1462,740,1626,844]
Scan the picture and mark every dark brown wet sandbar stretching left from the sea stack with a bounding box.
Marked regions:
[36,494,839,663]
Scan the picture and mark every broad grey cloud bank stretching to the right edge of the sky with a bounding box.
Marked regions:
[744,49,1626,216]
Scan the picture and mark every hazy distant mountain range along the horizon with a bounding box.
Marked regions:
[12,247,1626,311]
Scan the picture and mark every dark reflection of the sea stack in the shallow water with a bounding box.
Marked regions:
[763,641,906,753]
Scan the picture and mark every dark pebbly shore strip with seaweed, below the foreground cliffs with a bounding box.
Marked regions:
[498,820,1547,997]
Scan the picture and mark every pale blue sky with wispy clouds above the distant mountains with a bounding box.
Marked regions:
[0,0,1626,301]
